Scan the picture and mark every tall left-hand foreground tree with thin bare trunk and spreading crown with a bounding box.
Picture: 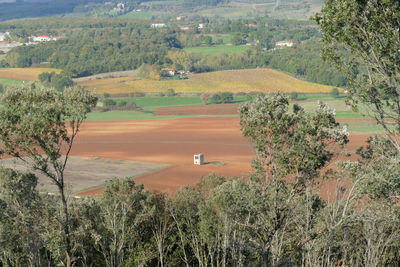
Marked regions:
[0,85,96,266]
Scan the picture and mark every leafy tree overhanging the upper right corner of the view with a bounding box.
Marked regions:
[315,0,400,151]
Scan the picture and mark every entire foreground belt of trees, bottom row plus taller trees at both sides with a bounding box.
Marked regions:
[0,0,400,266]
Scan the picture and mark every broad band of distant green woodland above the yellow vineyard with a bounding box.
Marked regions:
[0,16,345,86]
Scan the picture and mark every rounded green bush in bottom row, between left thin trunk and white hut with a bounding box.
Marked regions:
[92,178,151,266]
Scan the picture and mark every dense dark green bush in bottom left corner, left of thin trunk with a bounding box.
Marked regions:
[0,169,46,265]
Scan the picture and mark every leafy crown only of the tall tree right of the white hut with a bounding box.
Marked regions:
[239,93,348,184]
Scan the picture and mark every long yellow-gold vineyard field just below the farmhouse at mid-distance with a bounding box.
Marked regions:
[79,69,333,94]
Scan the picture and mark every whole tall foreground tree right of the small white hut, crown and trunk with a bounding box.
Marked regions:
[239,93,348,266]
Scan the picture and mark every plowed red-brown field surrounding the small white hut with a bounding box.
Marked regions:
[72,117,367,198]
